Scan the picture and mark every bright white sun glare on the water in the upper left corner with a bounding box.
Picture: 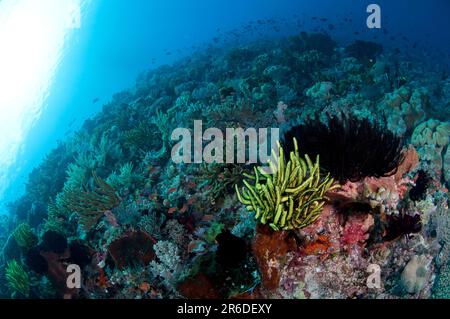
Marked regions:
[0,0,80,198]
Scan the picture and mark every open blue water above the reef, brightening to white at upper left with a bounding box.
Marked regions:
[0,0,450,210]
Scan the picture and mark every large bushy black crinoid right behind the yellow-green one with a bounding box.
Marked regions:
[283,114,403,183]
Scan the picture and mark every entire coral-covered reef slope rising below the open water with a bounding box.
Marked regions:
[0,32,450,299]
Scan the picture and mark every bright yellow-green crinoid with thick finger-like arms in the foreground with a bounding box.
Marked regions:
[235,139,338,231]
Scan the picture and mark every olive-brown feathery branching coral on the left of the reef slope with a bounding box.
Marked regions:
[60,173,119,231]
